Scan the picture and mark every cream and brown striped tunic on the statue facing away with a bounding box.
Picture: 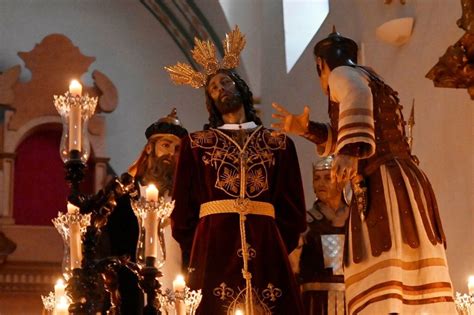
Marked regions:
[317,66,456,314]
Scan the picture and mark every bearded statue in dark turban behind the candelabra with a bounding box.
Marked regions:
[101,109,188,314]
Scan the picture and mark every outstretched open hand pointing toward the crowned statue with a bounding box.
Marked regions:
[271,103,309,135]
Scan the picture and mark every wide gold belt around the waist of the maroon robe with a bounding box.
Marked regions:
[199,199,275,218]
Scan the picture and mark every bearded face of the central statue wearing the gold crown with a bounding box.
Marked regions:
[207,73,243,115]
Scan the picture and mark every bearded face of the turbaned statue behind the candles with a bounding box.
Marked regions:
[139,134,181,193]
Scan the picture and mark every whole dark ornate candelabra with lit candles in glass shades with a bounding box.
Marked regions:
[49,81,201,315]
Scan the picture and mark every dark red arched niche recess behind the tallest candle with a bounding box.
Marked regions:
[12,123,95,226]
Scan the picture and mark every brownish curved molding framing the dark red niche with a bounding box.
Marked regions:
[0,34,118,224]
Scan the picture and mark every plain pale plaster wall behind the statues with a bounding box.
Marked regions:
[0,0,474,291]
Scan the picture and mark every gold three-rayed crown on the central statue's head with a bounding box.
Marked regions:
[165,26,245,89]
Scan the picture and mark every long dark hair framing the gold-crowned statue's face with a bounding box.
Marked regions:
[204,69,262,130]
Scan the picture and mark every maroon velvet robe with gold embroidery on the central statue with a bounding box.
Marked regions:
[171,127,306,315]
